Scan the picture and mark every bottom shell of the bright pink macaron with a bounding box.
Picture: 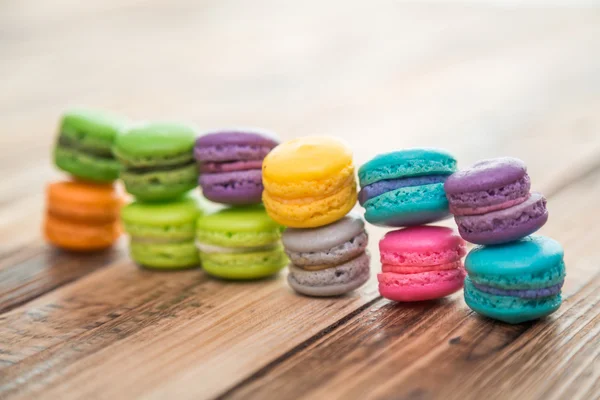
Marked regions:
[377,268,466,302]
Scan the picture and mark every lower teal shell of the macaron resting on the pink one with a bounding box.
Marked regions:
[364,183,450,227]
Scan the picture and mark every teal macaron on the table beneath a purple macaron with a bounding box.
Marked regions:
[465,235,565,324]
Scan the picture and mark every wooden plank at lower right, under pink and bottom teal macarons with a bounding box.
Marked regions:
[218,162,600,399]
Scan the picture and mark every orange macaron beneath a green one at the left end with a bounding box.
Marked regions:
[44,181,123,252]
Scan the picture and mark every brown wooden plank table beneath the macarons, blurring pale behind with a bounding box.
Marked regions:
[0,0,600,399]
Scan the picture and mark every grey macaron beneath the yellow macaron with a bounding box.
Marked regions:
[282,213,370,297]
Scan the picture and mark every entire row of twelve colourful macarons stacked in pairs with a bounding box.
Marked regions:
[44,109,565,323]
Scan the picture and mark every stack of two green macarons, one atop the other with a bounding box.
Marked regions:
[113,122,202,270]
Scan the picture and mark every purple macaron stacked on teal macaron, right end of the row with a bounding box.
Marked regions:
[444,157,565,323]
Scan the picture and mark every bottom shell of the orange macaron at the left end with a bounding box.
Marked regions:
[44,215,121,251]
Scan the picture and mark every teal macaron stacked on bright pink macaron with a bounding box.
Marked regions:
[358,148,466,301]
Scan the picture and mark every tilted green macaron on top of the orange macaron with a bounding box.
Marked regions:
[54,109,124,183]
